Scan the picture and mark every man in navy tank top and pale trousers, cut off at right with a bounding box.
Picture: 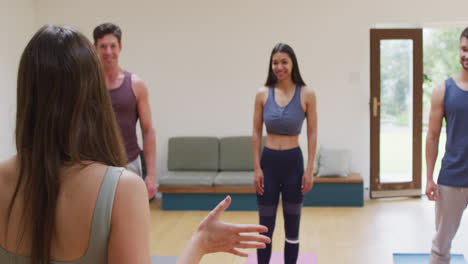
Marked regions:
[426,27,468,264]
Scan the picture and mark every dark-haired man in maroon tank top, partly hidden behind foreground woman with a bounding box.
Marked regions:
[93,23,156,199]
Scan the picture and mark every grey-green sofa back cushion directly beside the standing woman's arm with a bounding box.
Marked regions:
[219,136,254,171]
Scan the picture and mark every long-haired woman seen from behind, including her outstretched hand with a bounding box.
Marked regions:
[0,26,269,264]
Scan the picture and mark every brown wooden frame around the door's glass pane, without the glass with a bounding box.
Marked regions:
[369,28,423,198]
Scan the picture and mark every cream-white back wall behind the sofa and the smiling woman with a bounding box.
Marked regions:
[2,0,467,194]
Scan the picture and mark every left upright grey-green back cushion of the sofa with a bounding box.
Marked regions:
[167,137,219,171]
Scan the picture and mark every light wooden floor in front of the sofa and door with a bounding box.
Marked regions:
[150,198,468,264]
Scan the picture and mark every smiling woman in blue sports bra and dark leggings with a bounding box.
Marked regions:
[252,43,317,264]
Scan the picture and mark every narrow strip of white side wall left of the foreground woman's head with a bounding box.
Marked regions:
[0,0,35,160]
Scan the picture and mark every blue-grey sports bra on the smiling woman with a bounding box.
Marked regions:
[263,85,306,136]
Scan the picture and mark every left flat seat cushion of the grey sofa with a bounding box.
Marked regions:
[159,171,217,186]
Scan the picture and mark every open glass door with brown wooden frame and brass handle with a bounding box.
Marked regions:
[370,29,423,198]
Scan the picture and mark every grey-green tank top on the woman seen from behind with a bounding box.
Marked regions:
[0,167,124,264]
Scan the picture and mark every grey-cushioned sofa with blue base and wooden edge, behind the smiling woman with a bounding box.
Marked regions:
[159,136,364,210]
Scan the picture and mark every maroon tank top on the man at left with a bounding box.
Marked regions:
[109,71,141,162]
